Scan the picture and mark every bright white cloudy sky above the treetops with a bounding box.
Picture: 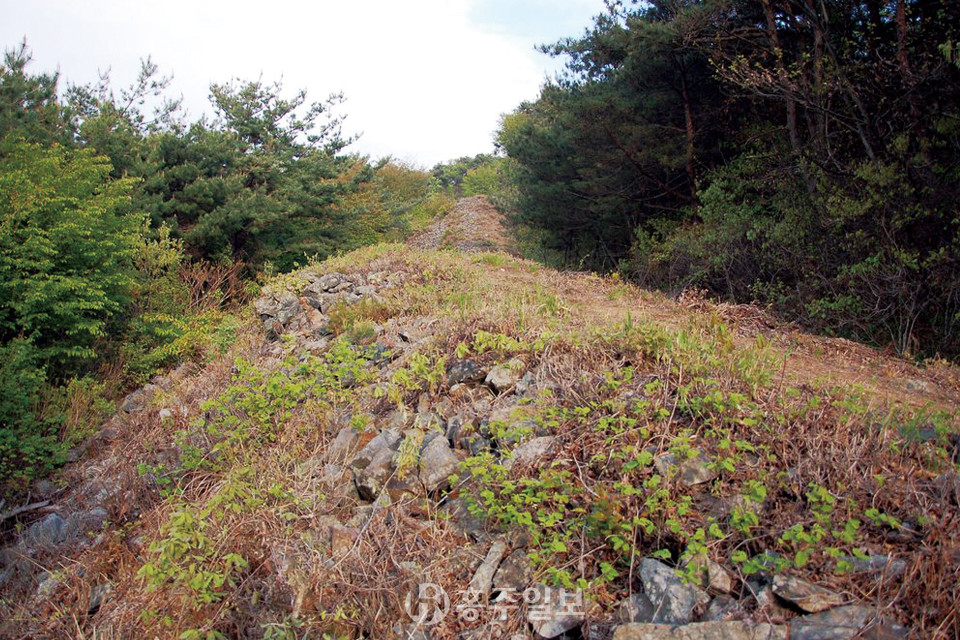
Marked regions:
[0,0,603,168]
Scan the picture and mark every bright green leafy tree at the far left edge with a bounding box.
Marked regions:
[0,140,142,370]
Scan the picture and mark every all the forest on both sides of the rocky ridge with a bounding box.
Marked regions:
[0,0,960,483]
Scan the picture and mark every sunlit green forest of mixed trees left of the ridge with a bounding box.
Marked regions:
[0,43,493,488]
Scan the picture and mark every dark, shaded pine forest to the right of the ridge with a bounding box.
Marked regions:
[498,0,960,358]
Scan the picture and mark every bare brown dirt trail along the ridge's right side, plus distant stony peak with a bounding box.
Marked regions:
[408,196,960,410]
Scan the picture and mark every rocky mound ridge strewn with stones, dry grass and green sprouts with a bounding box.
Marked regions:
[0,198,960,640]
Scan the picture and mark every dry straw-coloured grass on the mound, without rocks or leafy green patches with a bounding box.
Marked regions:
[0,246,960,638]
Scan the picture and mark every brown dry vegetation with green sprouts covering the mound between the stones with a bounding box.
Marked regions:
[0,201,960,639]
